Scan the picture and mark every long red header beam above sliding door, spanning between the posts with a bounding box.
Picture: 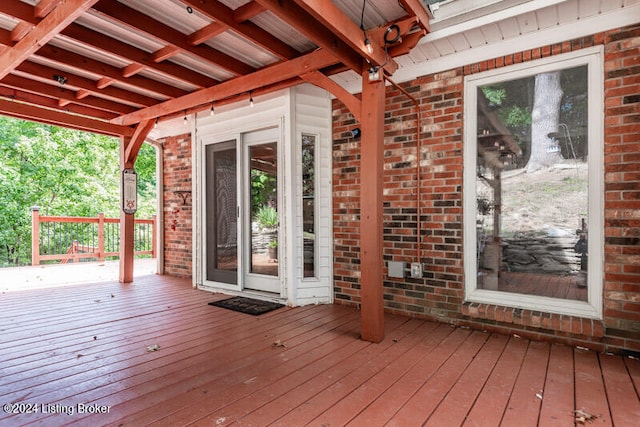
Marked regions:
[112,50,336,125]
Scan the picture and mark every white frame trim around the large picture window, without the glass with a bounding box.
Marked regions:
[463,46,604,319]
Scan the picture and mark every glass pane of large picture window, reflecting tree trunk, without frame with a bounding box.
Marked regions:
[476,66,589,301]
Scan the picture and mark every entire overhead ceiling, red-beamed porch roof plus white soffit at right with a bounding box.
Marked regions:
[0,0,640,137]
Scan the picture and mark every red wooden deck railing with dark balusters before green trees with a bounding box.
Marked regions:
[31,207,158,265]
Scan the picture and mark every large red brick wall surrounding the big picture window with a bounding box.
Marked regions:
[333,26,640,352]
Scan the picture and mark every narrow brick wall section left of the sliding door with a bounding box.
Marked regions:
[162,135,192,277]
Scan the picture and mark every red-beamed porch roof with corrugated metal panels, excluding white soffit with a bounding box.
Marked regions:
[0,0,429,137]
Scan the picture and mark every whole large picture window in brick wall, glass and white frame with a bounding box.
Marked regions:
[464,49,603,318]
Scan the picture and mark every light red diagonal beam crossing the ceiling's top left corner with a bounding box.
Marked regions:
[0,0,98,79]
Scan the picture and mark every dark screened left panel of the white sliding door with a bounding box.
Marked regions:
[206,141,238,283]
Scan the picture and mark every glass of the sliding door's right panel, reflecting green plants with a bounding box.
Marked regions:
[249,142,279,276]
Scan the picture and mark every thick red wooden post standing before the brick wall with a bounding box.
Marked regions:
[360,71,385,342]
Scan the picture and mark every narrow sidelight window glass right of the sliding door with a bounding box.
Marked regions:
[302,135,317,277]
